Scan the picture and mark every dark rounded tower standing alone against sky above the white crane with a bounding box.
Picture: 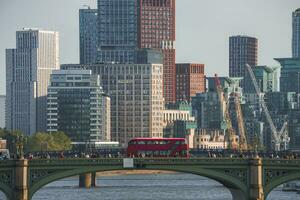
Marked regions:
[229,35,258,87]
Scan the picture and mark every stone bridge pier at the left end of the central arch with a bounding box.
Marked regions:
[13,159,29,200]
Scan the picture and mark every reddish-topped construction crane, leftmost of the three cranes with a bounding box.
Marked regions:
[215,74,237,149]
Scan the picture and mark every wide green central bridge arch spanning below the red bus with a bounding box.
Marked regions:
[29,165,248,200]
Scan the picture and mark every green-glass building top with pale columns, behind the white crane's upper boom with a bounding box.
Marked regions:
[244,66,279,93]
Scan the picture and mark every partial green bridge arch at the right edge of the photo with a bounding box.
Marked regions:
[264,172,300,199]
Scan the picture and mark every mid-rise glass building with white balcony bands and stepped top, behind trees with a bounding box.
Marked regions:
[47,70,110,149]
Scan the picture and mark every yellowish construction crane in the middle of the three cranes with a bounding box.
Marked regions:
[234,92,248,151]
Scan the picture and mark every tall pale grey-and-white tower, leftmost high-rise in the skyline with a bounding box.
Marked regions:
[6,29,59,134]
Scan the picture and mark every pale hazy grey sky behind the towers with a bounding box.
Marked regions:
[0,0,300,94]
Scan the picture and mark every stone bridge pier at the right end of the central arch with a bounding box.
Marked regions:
[249,157,265,200]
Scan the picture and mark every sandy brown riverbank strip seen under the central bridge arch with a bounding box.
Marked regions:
[97,169,178,176]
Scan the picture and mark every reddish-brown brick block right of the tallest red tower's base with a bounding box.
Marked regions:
[176,63,205,102]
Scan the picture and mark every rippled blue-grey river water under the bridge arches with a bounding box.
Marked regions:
[0,173,300,200]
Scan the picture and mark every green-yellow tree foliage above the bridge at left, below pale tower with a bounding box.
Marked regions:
[28,132,71,152]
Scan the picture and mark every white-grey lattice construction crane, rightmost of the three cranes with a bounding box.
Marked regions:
[246,64,289,151]
